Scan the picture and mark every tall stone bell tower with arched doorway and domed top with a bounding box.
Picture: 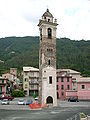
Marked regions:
[38,9,58,106]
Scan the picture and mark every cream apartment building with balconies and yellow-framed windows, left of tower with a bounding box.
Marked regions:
[23,67,39,96]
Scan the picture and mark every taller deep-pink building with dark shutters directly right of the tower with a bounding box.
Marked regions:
[57,72,72,100]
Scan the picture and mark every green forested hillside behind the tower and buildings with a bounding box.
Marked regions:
[0,36,90,76]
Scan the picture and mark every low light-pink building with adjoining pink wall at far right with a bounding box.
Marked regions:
[66,77,90,100]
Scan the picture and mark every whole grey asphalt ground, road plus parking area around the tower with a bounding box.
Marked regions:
[0,100,90,120]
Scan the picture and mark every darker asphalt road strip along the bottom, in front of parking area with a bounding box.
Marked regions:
[0,108,90,120]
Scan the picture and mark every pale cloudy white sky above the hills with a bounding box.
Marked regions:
[0,0,90,40]
